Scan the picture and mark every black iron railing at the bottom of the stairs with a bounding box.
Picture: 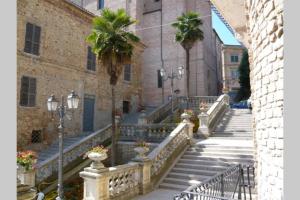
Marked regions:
[174,164,255,200]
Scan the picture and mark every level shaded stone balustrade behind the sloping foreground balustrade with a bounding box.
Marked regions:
[120,124,176,142]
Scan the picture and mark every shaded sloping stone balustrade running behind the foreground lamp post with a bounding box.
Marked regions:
[36,125,111,184]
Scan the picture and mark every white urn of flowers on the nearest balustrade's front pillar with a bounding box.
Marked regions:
[83,145,108,170]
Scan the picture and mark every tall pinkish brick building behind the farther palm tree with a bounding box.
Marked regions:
[72,0,218,106]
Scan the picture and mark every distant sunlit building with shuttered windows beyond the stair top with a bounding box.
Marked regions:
[222,44,245,101]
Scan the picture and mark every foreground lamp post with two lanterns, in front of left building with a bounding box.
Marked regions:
[47,91,79,200]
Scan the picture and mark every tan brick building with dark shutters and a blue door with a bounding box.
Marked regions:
[17,0,144,150]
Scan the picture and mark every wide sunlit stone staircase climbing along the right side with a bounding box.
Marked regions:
[159,109,253,192]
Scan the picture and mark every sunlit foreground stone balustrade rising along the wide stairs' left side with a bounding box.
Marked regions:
[80,115,193,200]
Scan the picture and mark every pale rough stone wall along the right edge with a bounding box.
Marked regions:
[246,0,284,200]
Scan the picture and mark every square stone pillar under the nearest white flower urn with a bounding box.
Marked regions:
[79,167,109,200]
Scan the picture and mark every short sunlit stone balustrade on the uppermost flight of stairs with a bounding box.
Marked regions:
[197,94,229,138]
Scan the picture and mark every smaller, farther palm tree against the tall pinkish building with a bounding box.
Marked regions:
[172,11,204,97]
